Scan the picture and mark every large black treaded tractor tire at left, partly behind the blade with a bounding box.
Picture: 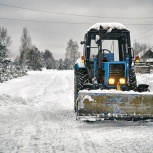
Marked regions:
[74,69,89,112]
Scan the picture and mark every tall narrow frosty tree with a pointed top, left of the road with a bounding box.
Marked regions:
[19,27,32,65]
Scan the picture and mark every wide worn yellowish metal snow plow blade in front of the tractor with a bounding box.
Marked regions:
[76,91,153,121]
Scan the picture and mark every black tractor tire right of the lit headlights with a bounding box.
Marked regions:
[129,69,137,91]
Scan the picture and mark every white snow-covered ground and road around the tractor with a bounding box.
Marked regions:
[0,70,153,153]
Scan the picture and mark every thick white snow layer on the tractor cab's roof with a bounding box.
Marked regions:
[87,22,126,32]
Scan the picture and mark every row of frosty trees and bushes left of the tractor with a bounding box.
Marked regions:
[0,27,80,83]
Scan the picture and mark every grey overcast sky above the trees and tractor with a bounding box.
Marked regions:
[0,0,153,59]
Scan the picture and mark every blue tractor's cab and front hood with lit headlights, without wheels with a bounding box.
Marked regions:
[82,24,134,90]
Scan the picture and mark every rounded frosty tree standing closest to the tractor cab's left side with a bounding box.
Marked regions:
[65,39,80,68]
